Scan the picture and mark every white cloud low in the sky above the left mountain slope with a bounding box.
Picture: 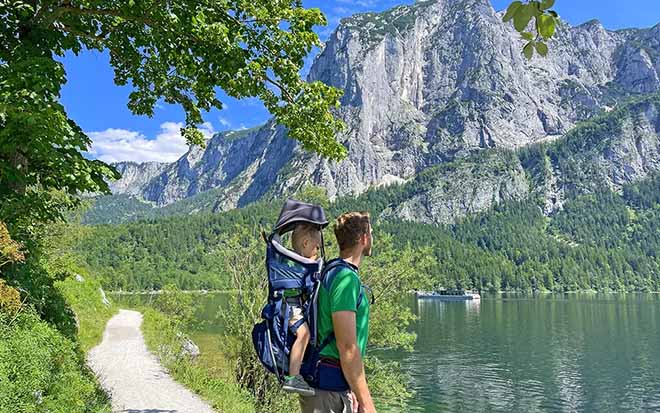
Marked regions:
[87,122,215,162]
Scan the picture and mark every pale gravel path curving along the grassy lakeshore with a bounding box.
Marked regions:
[87,310,214,413]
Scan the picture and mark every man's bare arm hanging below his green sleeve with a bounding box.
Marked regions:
[332,311,376,413]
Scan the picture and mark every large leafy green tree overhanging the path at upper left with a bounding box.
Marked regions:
[0,0,346,232]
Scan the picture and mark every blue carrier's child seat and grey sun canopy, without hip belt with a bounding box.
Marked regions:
[252,199,328,382]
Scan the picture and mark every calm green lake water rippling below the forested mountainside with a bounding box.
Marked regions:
[116,294,660,412]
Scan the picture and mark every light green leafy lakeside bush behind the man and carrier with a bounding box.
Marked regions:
[218,229,434,412]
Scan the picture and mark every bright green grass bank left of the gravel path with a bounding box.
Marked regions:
[0,268,115,413]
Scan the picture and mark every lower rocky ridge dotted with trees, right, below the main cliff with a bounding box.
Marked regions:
[383,94,660,224]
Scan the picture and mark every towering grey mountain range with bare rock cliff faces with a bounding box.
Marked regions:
[102,0,660,222]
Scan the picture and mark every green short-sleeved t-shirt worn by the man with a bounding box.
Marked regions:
[318,263,369,359]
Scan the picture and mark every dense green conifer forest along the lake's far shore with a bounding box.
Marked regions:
[77,171,660,291]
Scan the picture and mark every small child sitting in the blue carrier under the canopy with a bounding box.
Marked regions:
[283,223,321,396]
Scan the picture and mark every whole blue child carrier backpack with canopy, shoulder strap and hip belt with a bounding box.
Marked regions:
[252,200,363,391]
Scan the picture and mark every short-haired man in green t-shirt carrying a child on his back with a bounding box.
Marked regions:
[300,212,376,413]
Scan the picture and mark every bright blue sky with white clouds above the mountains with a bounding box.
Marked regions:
[61,0,660,162]
